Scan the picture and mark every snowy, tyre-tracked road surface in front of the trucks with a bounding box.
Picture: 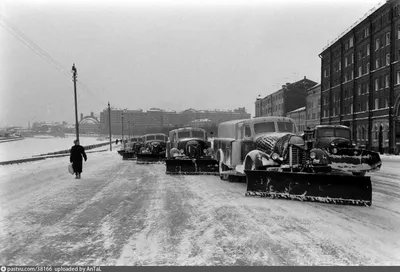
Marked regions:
[0,150,400,265]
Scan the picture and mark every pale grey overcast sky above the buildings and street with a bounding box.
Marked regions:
[0,0,382,126]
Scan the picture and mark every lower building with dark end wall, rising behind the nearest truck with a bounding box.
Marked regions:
[255,77,317,117]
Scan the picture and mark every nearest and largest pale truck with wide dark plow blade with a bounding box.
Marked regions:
[214,116,372,206]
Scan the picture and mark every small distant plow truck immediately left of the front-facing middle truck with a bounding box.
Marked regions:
[136,133,168,164]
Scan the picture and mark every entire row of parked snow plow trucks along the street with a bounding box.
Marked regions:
[116,117,382,206]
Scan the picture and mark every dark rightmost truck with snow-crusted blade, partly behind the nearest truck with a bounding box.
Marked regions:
[303,125,382,176]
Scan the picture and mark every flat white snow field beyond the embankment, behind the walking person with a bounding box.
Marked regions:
[0,137,109,161]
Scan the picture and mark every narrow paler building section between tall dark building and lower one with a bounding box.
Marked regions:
[306,84,321,129]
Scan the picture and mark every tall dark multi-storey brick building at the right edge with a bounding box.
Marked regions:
[320,0,400,153]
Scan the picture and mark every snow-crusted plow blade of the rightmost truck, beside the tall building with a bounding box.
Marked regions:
[329,148,382,172]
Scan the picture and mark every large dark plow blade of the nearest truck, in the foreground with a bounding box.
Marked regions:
[245,170,372,206]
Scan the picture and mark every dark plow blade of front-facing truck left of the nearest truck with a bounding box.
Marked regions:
[165,159,219,176]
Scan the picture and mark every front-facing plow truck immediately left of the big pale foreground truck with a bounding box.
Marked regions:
[165,127,219,175]
